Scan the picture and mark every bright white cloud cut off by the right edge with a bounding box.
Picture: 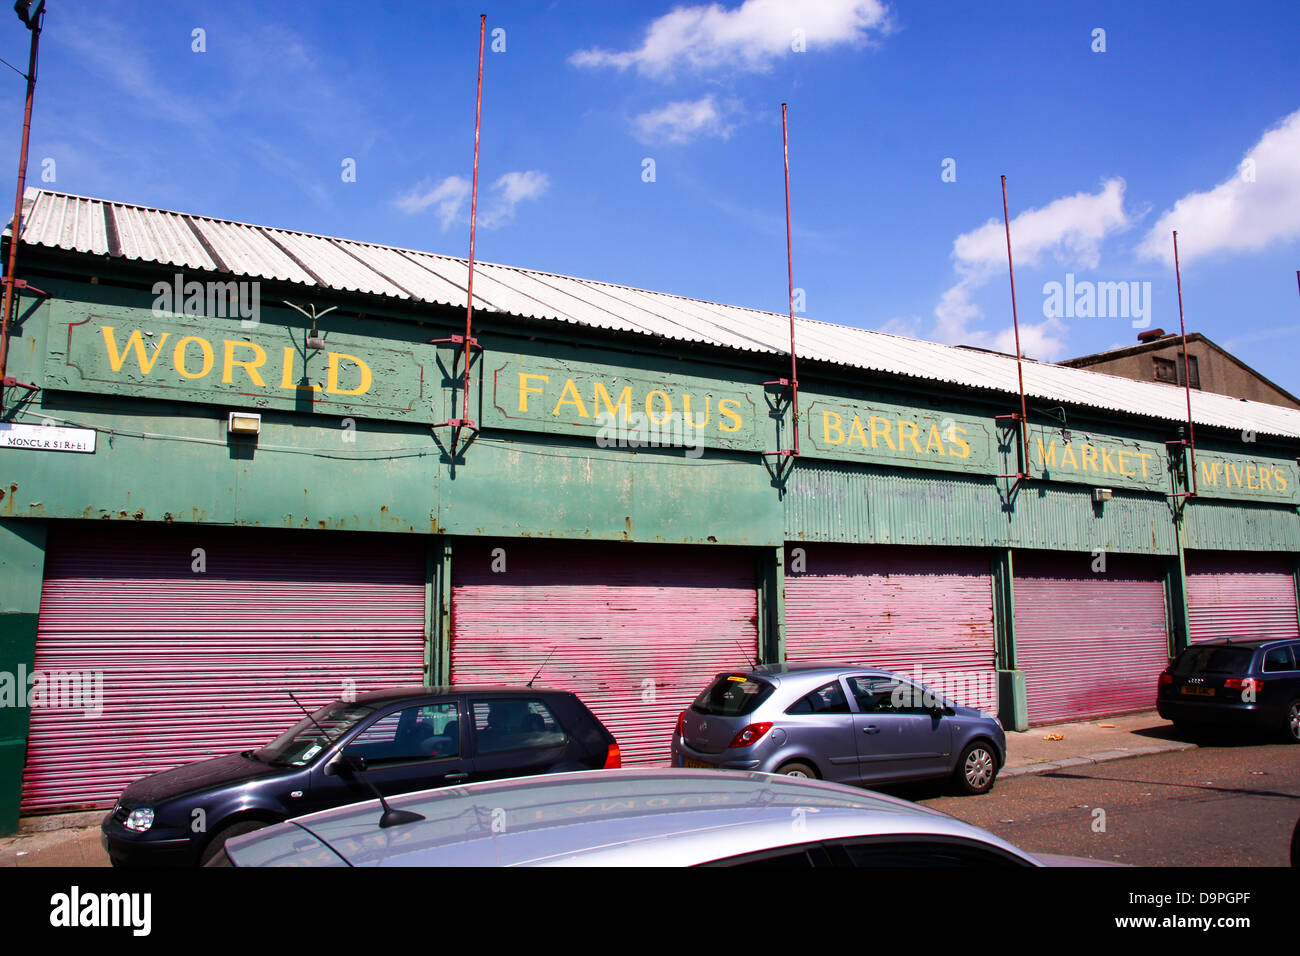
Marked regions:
[1138,111,1300,267]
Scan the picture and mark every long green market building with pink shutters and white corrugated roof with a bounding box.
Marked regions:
[0,190,1300,832]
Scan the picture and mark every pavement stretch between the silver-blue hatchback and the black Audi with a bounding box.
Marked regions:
[1000,710,1196,777]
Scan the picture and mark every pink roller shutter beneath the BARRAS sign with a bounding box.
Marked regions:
[785,545,997,710]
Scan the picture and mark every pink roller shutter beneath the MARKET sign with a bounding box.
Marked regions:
[1014,551,1169,723]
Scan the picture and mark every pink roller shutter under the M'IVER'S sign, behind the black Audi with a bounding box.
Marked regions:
[1187,551,1300,641]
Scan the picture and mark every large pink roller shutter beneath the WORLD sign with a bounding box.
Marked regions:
[22,524,425,813]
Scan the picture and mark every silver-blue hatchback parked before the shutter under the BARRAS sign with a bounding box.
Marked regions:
[672,665,1006,793]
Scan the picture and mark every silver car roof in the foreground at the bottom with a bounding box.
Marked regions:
[228,769,1037,866]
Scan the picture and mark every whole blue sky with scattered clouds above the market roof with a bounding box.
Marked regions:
[0,0,1300,393]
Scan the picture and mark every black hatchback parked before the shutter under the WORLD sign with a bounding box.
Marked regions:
[101,687,621,866]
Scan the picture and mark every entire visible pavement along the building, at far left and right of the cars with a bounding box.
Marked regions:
[0,711,1196,866]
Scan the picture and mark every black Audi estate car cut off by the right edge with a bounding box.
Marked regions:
[1156,639,1300,743]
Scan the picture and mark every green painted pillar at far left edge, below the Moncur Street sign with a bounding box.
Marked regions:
[0,519,46,835]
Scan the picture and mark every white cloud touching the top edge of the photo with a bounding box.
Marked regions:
[569,0,889,77]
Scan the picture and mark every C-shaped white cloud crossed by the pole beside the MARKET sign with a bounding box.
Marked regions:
[931,178,1130,360]
